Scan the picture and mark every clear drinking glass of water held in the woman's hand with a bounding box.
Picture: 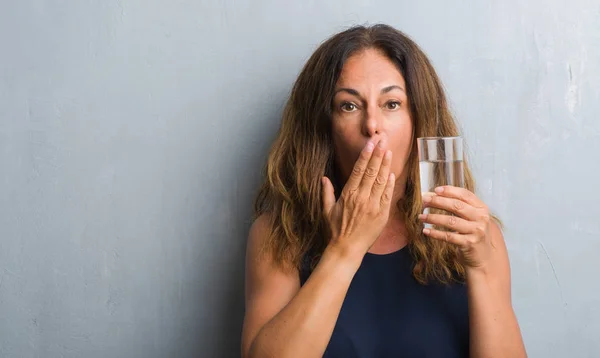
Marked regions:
[417,137,465,230]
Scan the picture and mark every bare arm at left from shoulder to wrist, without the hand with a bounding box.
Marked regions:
[242,215,360,358]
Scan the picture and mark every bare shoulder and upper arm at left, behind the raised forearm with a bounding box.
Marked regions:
[242,215,300,356]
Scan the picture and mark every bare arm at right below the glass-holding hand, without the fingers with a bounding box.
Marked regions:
[467,223,527,358]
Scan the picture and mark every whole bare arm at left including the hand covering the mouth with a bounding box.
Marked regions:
[242,141,395,358]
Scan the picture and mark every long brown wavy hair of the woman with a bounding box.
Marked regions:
[254,24,475,284]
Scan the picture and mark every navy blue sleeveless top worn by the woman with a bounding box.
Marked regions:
[300,247,469,358]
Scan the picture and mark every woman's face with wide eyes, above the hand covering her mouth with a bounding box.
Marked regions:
[332,49,413,189]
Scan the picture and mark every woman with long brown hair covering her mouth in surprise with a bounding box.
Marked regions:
[242,25,526,358]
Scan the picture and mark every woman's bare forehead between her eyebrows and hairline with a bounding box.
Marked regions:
[337,49,404,87]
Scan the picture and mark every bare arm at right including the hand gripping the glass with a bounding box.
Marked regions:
[420,186,527,358]
